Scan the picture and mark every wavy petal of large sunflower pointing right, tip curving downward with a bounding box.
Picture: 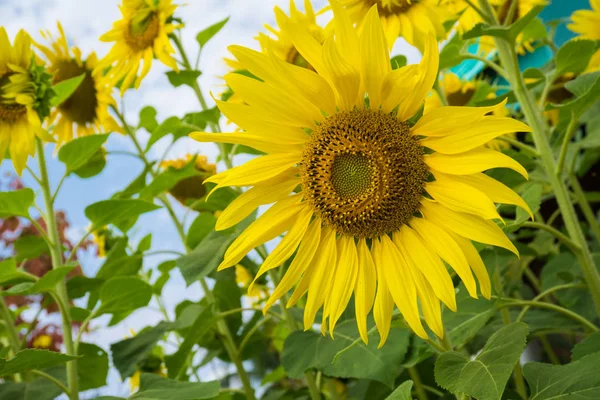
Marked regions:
[424,148,528,179]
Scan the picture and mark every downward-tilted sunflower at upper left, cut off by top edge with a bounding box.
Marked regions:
[98,0,181,96]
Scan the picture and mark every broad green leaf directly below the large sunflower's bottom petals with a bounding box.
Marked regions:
[281,319,410,388]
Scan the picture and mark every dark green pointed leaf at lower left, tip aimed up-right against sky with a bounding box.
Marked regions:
[110,322,170,379]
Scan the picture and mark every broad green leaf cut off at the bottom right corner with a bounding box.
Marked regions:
[523,353,600,400]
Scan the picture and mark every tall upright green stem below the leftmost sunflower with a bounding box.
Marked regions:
[35,138,79,400]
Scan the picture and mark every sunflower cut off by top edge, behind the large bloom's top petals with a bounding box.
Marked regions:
[341,0,453,51]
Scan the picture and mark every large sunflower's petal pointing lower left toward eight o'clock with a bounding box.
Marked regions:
[217,195,307,271]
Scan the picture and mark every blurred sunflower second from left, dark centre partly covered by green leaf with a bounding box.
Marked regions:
[36,23,120,145]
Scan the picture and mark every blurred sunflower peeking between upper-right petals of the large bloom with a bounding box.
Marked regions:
[423,72,515,151]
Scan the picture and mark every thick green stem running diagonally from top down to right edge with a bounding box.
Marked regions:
[479,0,600,315]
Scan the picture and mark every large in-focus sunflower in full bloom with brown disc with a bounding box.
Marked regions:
[191,0,530,346]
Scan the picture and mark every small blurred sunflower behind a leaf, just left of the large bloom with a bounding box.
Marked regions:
[160,154,217,205]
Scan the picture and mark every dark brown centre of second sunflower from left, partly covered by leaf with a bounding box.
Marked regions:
[53,60,98,125]
